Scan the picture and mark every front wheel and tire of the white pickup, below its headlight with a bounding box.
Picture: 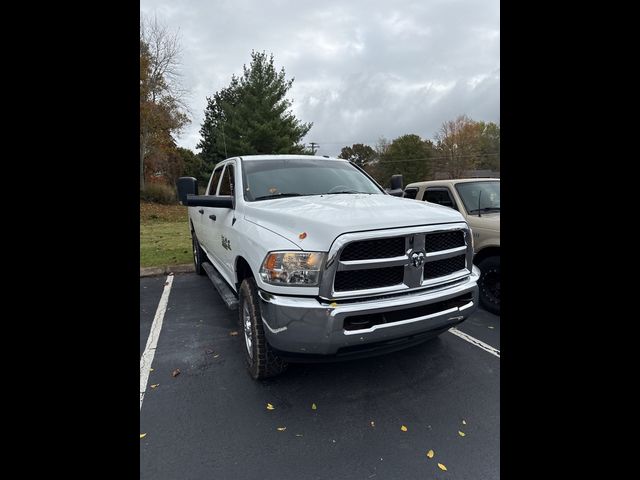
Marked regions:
[238,278,287,380]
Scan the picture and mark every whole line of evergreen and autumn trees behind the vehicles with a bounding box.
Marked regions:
[140,19,500,196]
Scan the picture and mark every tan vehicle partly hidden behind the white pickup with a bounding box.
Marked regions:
[403,178,500,315]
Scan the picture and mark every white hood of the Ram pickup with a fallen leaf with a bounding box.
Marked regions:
[244,194,464,252]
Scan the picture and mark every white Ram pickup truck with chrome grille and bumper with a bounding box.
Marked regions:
[178,155,479,379]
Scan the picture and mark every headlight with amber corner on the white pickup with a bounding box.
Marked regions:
[260,252,325,287]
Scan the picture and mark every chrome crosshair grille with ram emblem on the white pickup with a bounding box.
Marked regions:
[324,224,473,298]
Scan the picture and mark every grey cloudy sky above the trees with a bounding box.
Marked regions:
[140,0,500,155]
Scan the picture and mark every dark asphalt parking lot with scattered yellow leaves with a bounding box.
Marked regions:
[140,274,500,480]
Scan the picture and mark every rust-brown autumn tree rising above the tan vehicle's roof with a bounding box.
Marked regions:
[436,115,481,178]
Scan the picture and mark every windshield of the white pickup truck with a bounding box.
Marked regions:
[242,158,383,202]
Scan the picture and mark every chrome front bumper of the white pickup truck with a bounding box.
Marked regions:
[259,266,480,355]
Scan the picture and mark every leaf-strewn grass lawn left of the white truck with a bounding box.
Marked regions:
[140,202,193,267]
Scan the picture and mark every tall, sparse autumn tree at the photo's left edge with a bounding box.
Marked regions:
[140,13,189,190]
